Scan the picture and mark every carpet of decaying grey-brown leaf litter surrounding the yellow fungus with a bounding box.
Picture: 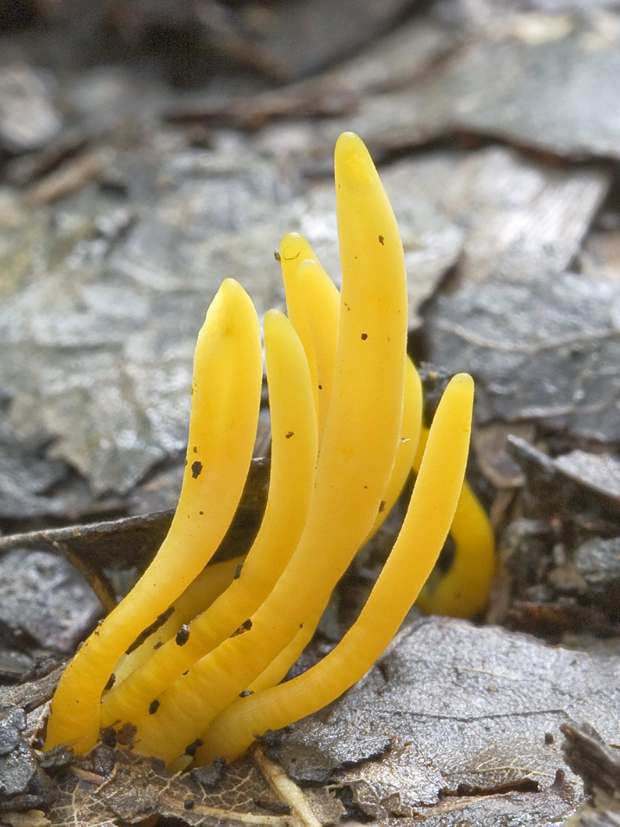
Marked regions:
[0,2,620,827]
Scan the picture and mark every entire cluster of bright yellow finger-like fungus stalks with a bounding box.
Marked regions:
[46,133,493,768]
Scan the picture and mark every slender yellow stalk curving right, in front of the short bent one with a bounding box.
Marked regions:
[198,374,473,763]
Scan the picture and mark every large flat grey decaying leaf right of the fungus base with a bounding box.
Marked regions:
[271,618,620,825]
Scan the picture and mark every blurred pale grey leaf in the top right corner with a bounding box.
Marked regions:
[344,16,620,163]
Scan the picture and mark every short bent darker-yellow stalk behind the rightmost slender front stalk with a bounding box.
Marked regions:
[414,428,495,618]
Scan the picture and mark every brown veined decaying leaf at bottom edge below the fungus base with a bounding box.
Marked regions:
[48,747,344,827]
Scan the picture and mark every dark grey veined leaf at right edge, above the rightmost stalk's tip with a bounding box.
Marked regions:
[430,273,620,441]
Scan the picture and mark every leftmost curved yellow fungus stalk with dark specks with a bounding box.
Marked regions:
[45,279,262,752]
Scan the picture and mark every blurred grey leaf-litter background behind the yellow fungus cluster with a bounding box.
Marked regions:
[0,0,620,652]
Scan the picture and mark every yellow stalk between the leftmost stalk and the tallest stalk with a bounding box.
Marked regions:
[101,310,317,727]
